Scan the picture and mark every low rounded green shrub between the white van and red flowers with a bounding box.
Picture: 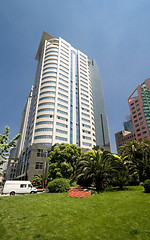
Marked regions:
[47,178,70,193]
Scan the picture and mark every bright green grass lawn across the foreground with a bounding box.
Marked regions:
[0,186,150,240]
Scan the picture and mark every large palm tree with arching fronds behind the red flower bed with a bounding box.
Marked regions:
[72,150,119,191]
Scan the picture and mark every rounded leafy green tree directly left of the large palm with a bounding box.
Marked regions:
[48,143,83,180]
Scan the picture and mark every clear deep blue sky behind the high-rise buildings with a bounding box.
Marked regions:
[0,0,150,152]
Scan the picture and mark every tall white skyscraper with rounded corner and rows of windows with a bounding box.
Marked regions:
[14,32,109,179]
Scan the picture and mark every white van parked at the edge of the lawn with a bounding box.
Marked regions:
[2,181,37,196]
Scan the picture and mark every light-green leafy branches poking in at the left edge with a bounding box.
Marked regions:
[0,126,21,165]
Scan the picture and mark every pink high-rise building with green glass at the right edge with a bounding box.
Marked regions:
[128,78,150,141]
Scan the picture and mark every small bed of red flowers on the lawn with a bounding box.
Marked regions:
[68,188,91,198]
